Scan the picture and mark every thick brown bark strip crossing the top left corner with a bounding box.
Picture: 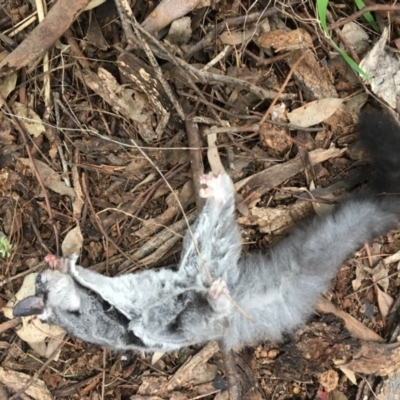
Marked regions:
[0,0,90,76]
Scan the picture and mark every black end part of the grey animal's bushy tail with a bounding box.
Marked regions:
[358,111,400,194]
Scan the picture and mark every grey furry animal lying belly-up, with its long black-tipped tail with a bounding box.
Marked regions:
[14,113,400,351]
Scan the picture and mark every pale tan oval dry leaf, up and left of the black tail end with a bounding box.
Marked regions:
[287,97,343,128]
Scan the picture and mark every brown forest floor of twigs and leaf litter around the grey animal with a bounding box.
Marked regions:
[0,0,400,400]
